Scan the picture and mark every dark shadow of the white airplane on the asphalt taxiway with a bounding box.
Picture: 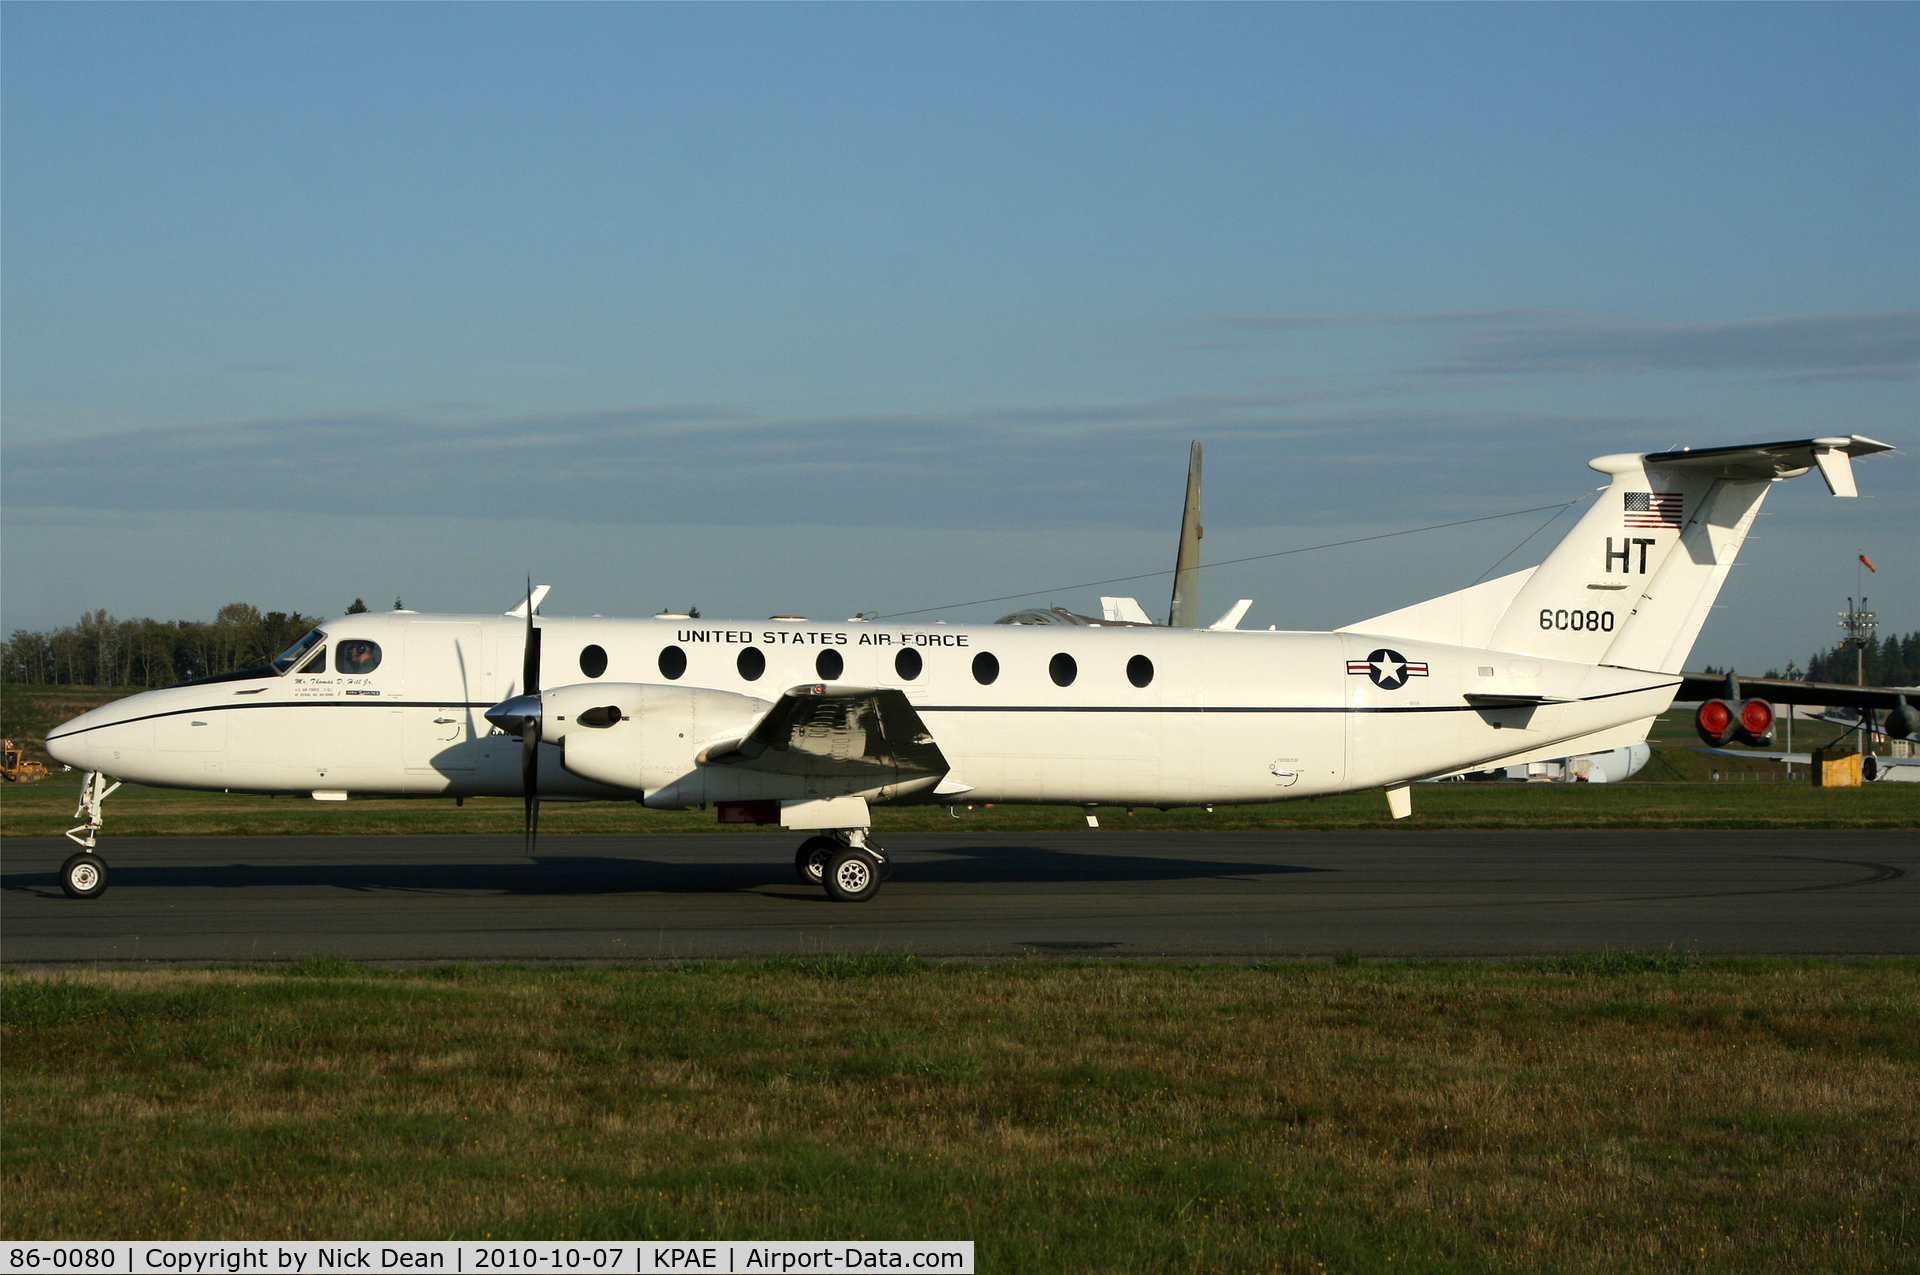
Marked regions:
[0,845,1331,902]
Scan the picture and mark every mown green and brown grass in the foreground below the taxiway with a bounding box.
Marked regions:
[0,952,1920,1273]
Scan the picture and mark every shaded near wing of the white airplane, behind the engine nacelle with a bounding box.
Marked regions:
[701,682,948,780]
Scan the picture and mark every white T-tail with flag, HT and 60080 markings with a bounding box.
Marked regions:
[1488,436,1891,672]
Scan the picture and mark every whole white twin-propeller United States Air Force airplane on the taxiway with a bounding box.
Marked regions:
[46,436,1889,901]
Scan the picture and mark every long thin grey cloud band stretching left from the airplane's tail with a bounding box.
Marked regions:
[0,394,1692,534]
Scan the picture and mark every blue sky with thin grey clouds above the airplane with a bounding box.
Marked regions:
[0,4,1920,672]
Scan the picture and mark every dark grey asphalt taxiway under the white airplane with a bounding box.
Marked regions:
[0,831,1920,964]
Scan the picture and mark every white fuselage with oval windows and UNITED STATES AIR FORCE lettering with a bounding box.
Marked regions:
[37,613,1678,806]
